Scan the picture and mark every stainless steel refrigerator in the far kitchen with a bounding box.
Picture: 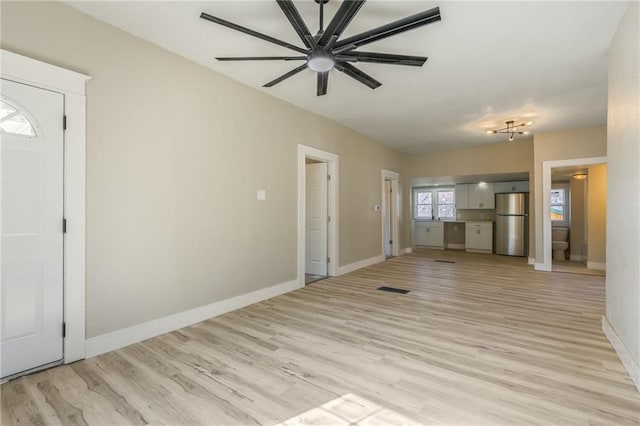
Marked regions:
[496,192,529,256]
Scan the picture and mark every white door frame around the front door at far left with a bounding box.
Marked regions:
[0,49,91,364]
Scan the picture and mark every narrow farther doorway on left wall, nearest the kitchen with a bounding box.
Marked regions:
[382,169,400,259]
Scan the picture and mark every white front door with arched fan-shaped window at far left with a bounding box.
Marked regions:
[0,79,64,377]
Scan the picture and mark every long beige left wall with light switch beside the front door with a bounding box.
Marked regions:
[1,2,408,337]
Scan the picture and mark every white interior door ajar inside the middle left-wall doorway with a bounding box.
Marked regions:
[305,163,329,276]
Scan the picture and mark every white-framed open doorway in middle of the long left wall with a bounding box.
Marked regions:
[298,145,338,287]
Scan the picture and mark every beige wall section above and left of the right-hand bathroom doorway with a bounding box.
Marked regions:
[530,127,607,263]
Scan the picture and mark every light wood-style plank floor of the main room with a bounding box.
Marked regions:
[1,251,640,425]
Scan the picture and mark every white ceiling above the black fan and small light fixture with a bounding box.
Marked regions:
[69,0,628,153]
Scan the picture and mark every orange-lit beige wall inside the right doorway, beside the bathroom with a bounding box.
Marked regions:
[587,165,607,269]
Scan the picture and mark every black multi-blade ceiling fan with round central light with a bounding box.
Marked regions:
[200,0,440,96]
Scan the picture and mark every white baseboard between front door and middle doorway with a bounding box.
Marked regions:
[85,280,300,358]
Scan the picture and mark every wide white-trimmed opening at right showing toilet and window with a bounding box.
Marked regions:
[543,157,607,276]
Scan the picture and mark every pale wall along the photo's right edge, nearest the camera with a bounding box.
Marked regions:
[606,2,640,389]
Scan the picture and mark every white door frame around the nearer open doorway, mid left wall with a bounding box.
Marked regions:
[297,144,339,288]
